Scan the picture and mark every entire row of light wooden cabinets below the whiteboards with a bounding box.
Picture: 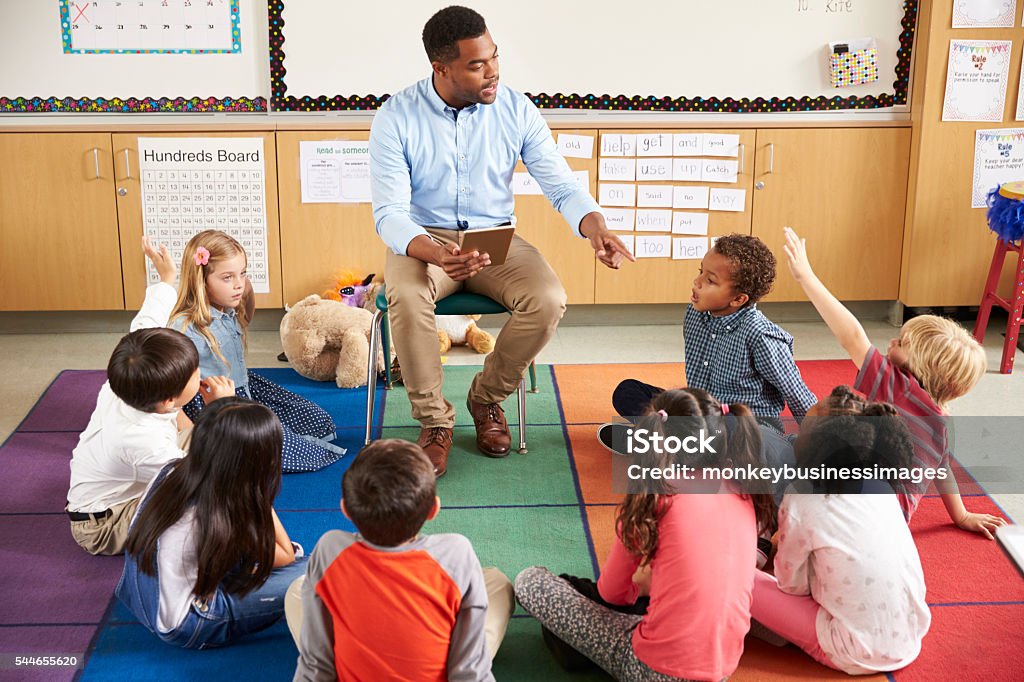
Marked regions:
[0,124,913,310]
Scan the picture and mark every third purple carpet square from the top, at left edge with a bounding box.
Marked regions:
[0,513,124,626]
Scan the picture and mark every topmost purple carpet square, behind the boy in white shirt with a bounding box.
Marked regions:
[17,370,106,432]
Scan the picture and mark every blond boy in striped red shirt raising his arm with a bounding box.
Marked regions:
[783,227,1006,540]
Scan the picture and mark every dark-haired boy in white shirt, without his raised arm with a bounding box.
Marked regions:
[67,328,234,554]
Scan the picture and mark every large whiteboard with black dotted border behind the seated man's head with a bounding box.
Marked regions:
[270,0,916,112]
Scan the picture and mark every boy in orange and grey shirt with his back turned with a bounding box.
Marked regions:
[288,439,514,680]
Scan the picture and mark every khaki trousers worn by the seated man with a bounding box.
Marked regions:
[384,228,565,428]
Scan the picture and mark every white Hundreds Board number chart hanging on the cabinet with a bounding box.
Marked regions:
[138,137,270,294]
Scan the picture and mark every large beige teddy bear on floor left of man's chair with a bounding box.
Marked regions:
[281,294,383,388]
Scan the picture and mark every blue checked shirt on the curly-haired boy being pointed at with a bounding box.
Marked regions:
[683,305,817,425]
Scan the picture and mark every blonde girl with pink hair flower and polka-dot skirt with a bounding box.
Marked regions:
[169,229,345,472]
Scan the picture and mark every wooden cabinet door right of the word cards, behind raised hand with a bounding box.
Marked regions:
[752,128,910,301]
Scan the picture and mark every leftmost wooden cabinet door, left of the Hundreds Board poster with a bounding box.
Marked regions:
[0,132,125,310]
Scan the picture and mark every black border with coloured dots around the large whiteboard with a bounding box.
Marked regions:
[268,0,919,114]
